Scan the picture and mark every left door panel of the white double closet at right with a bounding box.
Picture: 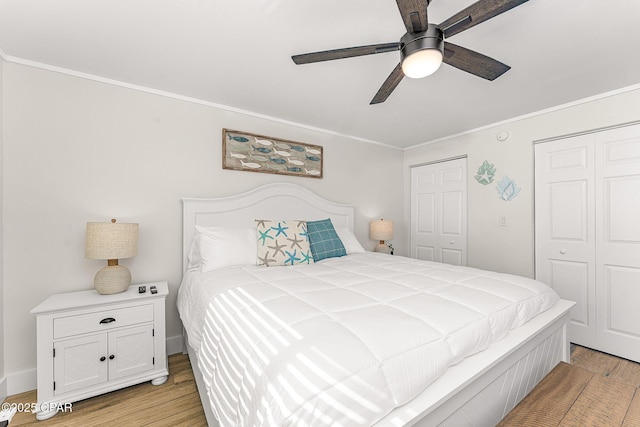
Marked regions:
[535,135,597,348]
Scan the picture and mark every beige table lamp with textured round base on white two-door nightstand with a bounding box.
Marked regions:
[85,219,138,295]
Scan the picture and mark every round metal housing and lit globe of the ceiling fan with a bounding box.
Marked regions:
[400,25,444,79]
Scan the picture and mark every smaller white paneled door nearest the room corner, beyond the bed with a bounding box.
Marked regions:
[411,158,467,265]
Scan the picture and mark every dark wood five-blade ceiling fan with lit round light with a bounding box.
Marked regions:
[291,0,528,104]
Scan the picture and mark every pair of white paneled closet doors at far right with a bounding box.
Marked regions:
[535,125,640,361]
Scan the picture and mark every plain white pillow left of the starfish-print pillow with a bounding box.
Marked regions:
[196,225,258,273]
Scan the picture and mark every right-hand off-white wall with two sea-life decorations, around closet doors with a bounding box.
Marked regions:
[404,87,640,277]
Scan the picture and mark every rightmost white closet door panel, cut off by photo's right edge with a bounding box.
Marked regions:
[595,125,640,361]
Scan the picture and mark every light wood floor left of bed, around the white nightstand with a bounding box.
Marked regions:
[5,354,207,427]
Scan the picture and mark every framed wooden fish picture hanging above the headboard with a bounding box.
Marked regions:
[222,129,323,178]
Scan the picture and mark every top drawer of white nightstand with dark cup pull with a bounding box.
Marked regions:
[53,304,153,338]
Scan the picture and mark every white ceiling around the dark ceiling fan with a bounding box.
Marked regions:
[0,0,640,147]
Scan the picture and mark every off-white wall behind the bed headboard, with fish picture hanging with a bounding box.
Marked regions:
[3,62,406,386]
